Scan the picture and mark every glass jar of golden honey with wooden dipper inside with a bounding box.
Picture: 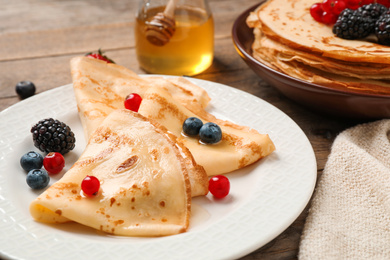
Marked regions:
[134,0,214,76]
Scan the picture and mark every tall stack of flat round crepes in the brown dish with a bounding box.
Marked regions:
[246,0,390,94]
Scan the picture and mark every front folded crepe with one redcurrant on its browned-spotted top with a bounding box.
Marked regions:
[30,109,191,236]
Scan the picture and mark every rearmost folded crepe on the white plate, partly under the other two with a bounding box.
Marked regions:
[70,57,210,197]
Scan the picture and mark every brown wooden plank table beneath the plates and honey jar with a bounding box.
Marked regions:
[0,0,370,260]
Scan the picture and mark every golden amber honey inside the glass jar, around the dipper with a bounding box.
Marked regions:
[135,6,214,76]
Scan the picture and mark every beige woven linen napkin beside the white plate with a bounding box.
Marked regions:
[299,120,390,260]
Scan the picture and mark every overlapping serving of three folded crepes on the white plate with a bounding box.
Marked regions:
[30,57,275,236]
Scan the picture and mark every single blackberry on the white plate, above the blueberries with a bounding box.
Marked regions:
[31,118,76,154]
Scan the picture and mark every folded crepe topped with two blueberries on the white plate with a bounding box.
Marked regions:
[138,88,275,176]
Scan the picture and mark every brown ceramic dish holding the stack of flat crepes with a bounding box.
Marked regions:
[232,1,390,119]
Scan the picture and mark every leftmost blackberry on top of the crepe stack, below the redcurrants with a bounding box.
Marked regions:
[333,8,375,40]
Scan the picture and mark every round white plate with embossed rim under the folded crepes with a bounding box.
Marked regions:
[0,79,317,260]
